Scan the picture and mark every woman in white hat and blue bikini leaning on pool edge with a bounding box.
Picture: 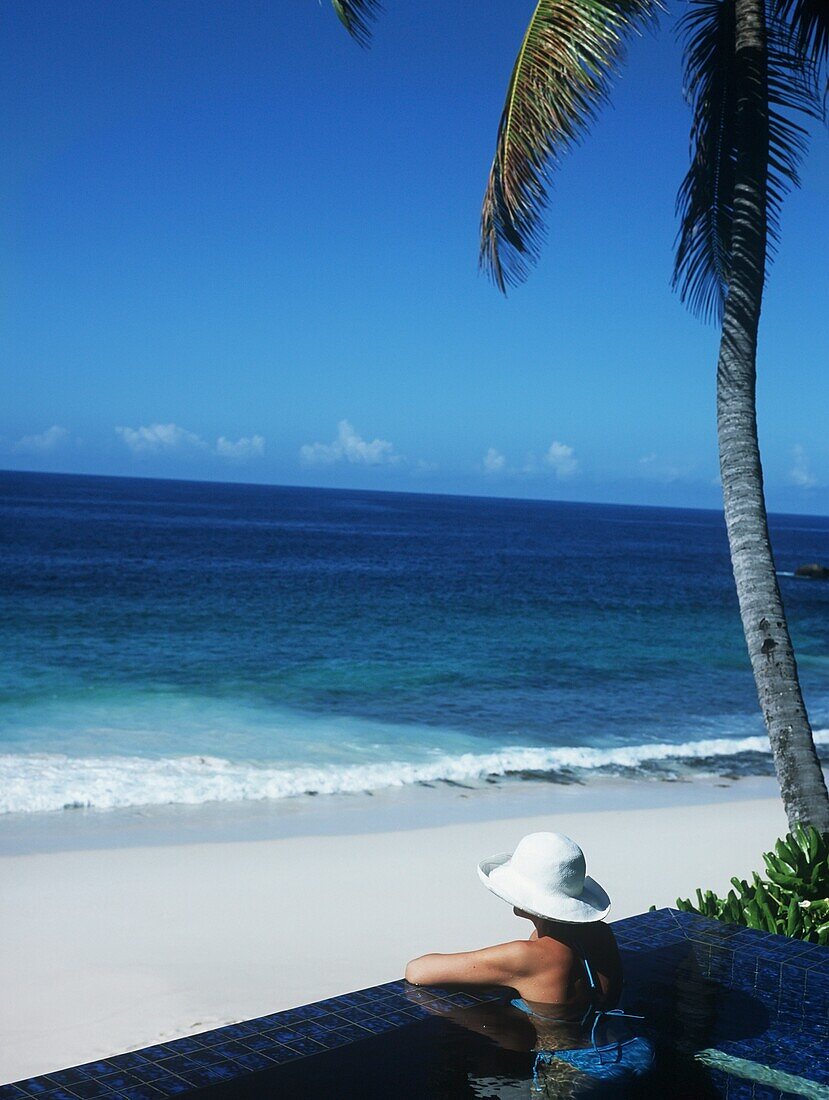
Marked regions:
[406,833,653,1095]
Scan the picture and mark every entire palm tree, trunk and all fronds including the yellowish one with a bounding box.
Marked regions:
[332,0,829,833]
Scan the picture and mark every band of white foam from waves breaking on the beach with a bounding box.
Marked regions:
[0,729,829,813]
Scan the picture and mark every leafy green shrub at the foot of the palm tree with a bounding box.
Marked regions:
[676,825,829,946]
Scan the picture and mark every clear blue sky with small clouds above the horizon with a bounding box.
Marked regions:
[0,0,829,513]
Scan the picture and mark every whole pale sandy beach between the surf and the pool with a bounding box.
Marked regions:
[0,780,786,1082]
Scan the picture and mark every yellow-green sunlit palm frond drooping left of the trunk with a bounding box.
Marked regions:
[480,0,659,290]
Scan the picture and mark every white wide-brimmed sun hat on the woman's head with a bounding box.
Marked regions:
[478,833,610,924]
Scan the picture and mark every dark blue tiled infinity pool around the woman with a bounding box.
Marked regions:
[0,910,829,1100]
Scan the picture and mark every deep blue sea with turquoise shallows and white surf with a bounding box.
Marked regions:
[0,473,829,812]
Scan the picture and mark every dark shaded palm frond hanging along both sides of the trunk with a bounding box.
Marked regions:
[672,0,820,320]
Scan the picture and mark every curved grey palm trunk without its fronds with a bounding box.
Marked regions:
[717,0,829,833]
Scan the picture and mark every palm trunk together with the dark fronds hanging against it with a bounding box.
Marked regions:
[674,0,829,833]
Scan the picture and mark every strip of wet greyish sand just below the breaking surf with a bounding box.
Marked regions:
[0,774,780,858]
